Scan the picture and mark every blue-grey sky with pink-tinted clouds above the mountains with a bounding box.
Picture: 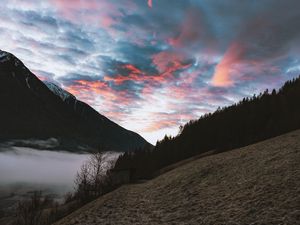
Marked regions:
[0,0,300,144]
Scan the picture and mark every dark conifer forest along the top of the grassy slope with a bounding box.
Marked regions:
[115,76,300,179]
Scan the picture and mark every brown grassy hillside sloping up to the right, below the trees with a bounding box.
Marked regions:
[55,130,300,225]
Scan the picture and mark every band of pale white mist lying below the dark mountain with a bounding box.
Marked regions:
[0,147,119,194]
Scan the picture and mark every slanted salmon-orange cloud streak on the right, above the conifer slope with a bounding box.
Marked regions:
[212,43,243,87]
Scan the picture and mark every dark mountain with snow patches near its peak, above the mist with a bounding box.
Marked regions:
[0,50,149,151]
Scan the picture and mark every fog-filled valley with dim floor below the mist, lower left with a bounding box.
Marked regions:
[0,147,120,225]
